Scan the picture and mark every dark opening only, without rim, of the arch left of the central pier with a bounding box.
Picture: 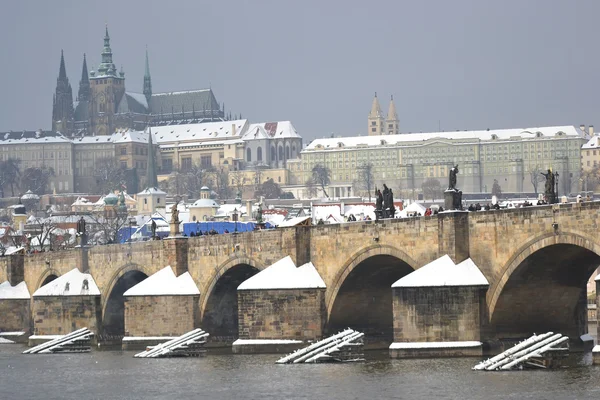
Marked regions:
[201,263,259,342]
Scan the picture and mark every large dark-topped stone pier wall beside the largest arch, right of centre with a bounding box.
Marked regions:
[392,287,485,342]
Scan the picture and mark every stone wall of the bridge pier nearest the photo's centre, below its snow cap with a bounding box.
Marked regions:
[238,289,327,340]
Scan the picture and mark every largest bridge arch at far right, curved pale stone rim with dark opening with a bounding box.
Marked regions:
[487,231,600,337]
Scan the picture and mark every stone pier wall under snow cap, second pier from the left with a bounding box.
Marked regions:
[33,296,102,335]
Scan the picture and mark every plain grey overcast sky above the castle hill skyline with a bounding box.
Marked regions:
[0,0,600,142]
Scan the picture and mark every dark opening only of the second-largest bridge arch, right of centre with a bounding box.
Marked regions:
[326,254,413,346]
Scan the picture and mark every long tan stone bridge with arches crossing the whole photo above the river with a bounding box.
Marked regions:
[0,202,600,346]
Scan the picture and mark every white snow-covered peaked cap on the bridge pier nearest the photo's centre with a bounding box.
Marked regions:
[238,256,326,290]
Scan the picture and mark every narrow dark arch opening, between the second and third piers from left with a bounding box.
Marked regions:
[102,270,148,338]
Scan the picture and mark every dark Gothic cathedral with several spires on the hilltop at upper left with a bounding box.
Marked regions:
[52,27,225,136]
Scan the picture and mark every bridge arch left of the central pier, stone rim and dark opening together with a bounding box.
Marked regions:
[200,253,265,341]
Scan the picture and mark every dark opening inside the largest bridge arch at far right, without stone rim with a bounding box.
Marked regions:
[490,243,600,339]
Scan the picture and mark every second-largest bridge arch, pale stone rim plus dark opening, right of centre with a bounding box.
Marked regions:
[325,245,417,346]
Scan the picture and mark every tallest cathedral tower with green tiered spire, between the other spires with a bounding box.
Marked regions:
[89,27,125,135]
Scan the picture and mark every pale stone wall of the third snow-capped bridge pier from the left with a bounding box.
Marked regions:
[125,296,199,336]
